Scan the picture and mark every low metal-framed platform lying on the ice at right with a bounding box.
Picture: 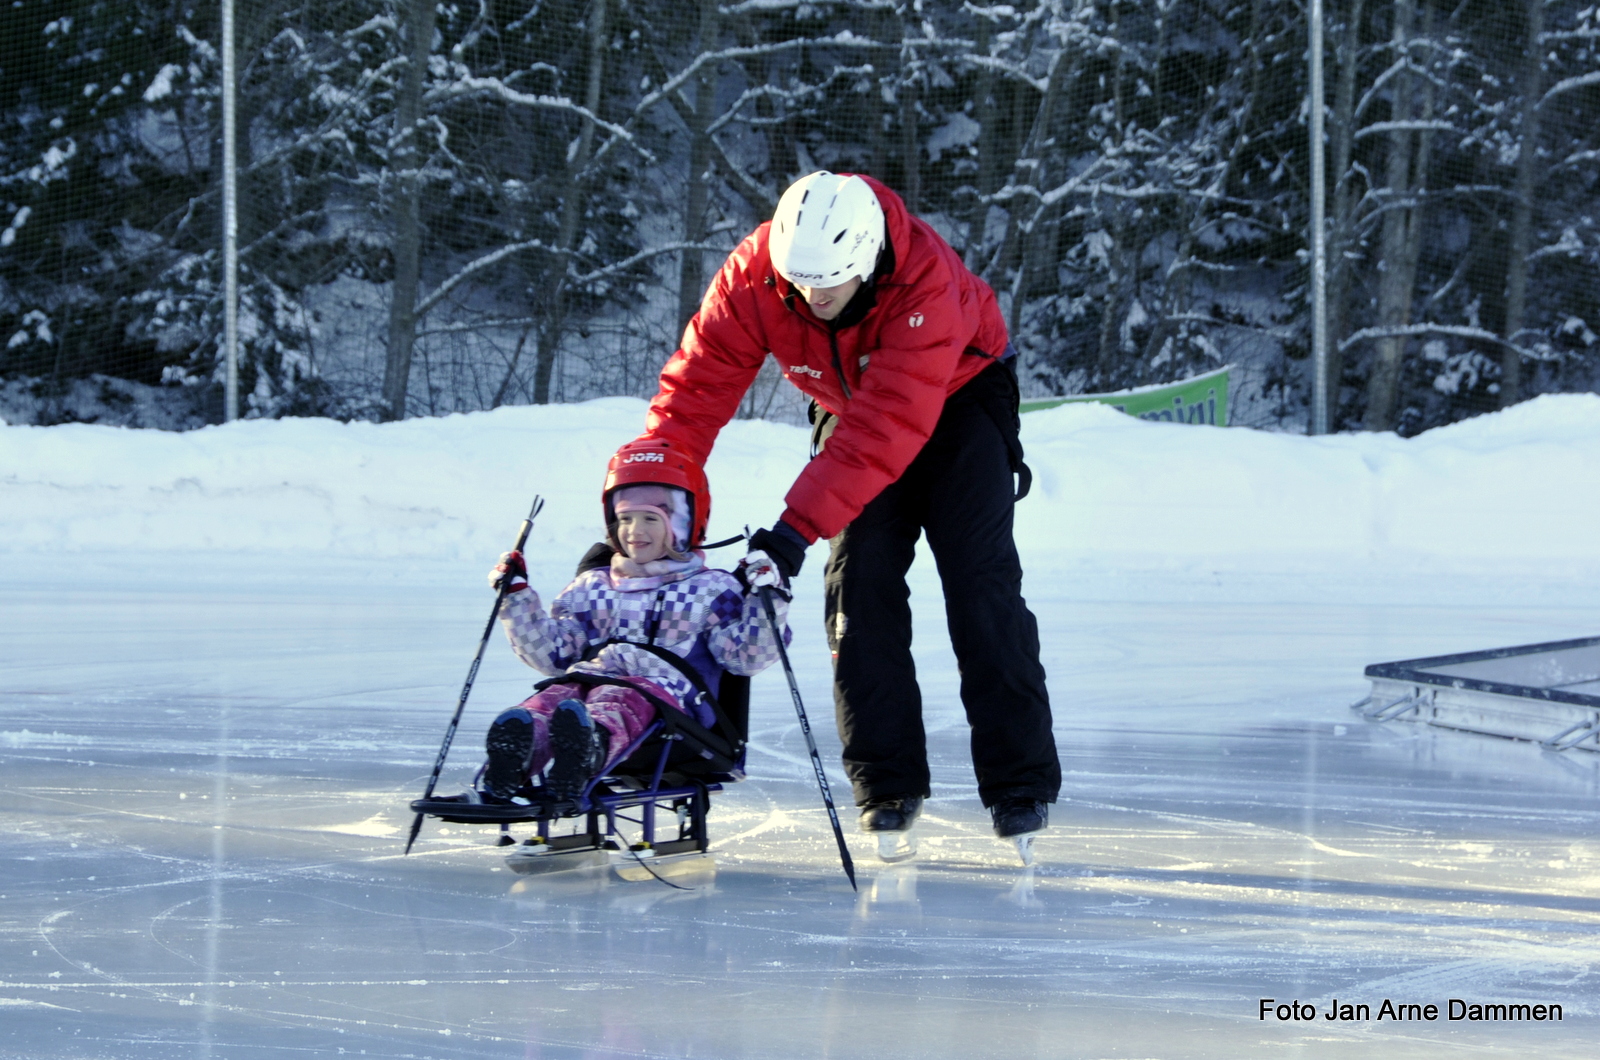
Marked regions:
[1350,637,1600,751]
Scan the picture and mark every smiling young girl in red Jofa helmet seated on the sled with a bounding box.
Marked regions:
[480,442,789,802]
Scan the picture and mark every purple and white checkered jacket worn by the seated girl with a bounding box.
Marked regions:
[501,554,790,729]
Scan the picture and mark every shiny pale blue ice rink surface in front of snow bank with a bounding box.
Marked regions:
[0,557,1600,1060]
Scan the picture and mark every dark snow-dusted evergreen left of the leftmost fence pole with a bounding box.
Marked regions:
[0,0,208,406]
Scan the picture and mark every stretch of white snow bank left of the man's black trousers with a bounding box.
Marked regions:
[0,397,793,565]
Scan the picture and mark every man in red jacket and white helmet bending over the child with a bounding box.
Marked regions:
[645,173,1061,852]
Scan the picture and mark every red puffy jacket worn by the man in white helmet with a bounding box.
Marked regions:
[645,176,1006,541]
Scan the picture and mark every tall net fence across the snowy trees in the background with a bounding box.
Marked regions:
[0,0,1600,434]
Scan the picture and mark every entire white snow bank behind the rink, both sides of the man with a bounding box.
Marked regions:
[0,394,1600,573]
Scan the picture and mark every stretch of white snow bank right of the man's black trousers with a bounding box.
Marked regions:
[1018,394,1600,570]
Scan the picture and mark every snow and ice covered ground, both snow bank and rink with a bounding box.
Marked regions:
[0,400,1600,1060]
